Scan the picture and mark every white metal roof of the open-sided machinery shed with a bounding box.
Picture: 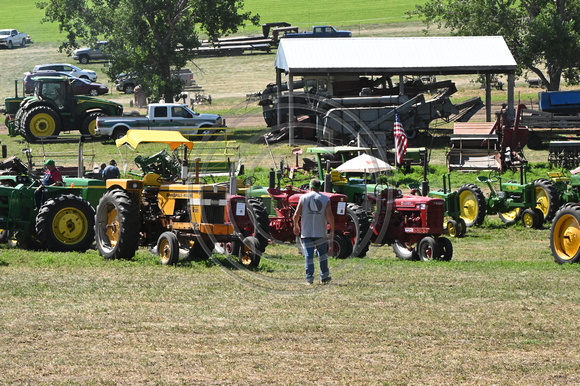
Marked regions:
[275,36,516,75]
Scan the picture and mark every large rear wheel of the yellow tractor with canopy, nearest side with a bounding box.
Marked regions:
[95,189,141,260]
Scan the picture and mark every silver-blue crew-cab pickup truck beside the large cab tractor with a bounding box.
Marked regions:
[95,103,225,139]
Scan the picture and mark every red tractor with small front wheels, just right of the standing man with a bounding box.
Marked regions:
[368,188,453,261]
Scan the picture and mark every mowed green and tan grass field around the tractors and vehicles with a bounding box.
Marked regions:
[0,0,580,385]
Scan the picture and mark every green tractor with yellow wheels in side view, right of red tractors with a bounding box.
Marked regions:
[458,165,557,229]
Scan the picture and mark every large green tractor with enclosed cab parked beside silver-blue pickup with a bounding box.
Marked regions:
[4,76,123,143]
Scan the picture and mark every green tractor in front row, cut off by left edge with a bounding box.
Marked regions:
[0,155,105,252]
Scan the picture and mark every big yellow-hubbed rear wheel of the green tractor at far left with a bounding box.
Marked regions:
[36,194,95,252]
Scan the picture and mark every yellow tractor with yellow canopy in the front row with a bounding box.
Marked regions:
[95,130,264,267]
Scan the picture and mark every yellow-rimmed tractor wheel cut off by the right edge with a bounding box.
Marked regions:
[550,204,580,264]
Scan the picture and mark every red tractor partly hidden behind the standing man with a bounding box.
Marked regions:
[253,173,370,259]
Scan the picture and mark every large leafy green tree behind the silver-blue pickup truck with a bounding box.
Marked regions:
[37,0,259,101]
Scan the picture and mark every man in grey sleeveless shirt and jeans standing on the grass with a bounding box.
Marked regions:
[292,178,334,284]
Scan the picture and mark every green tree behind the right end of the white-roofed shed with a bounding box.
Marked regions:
[409,0,580,91]
